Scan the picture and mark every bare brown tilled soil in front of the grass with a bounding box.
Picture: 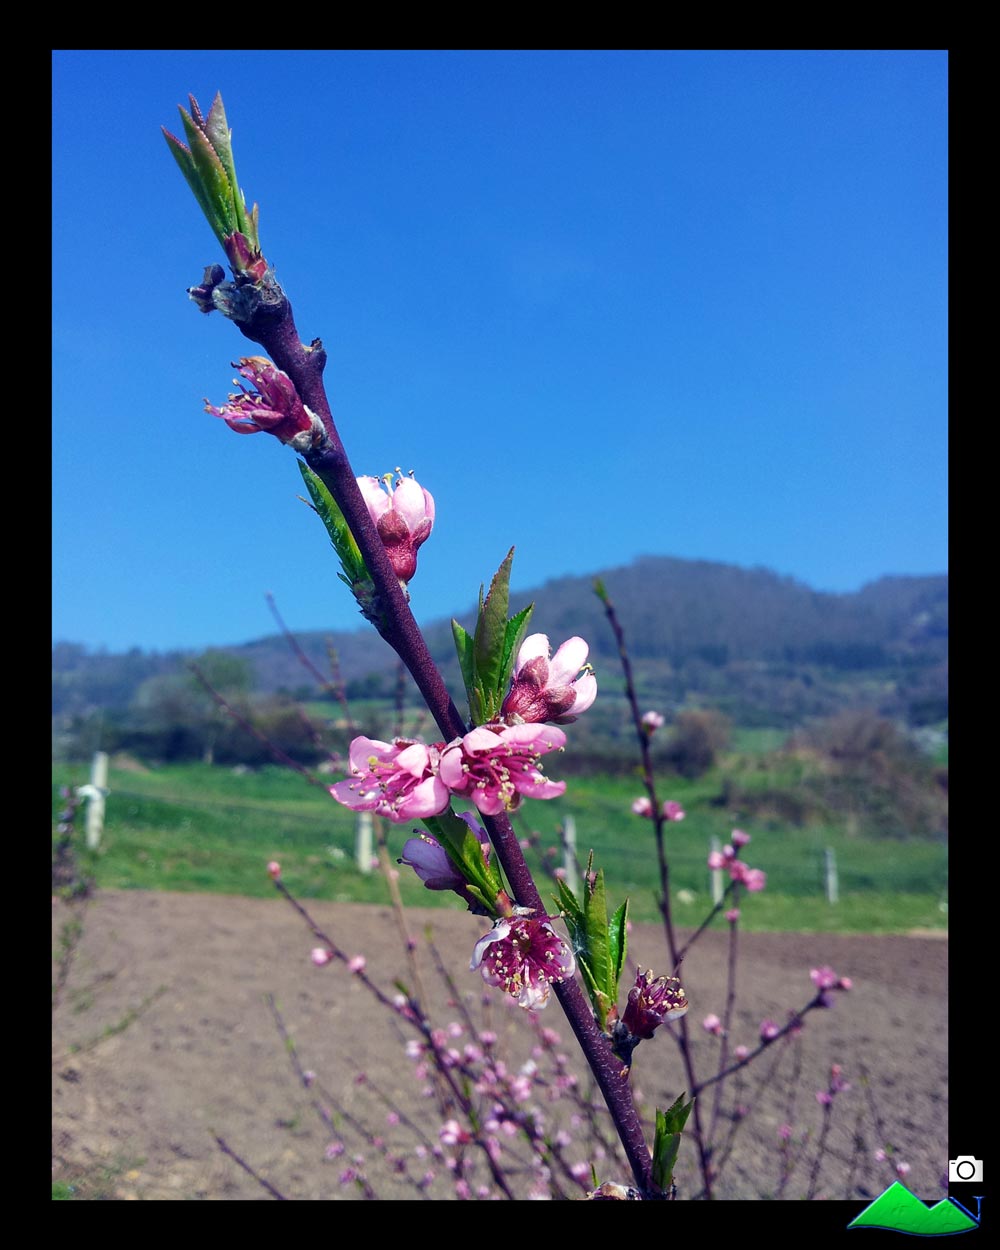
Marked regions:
[53,890,948,1201]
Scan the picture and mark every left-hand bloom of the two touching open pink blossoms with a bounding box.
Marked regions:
[330,738,449,824]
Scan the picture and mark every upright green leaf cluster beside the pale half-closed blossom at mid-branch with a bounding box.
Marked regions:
[451,548,535,725]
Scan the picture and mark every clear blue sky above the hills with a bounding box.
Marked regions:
[53,51,948,650]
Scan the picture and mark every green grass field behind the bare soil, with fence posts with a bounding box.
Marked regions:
[53,765,948,933]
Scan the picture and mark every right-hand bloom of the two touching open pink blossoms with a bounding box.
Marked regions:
[438,725,566,816]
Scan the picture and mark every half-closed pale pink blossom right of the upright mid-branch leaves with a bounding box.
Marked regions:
[500,634,598,725]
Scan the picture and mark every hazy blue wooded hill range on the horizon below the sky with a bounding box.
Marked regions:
[53,556,948,730]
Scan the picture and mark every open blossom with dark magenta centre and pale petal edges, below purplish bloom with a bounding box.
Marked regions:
[469,916,576,1011]
